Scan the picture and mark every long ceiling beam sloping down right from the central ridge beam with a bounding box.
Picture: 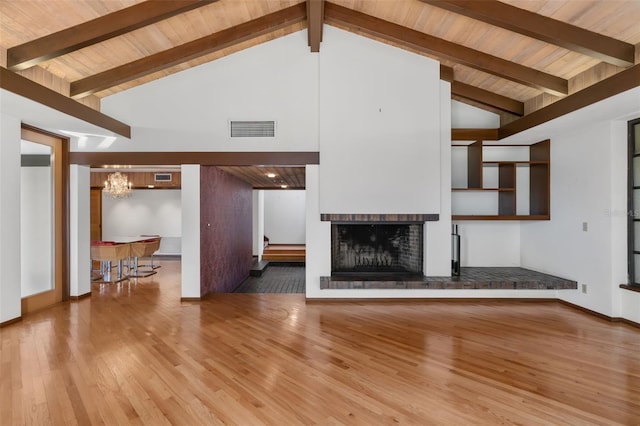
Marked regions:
[325,2,569,96]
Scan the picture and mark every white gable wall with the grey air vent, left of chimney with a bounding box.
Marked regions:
[97,30,318,151]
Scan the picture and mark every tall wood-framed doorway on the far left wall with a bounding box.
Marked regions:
[20,125,69,314]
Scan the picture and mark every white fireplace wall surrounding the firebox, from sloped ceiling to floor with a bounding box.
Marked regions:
[306,27,451,298]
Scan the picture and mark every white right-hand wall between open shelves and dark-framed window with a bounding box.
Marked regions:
[521,120,631,316]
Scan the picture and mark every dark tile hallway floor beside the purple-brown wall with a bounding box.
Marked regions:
[234,262,305,293]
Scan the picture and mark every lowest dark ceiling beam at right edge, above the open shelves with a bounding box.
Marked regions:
[499,64,640,139]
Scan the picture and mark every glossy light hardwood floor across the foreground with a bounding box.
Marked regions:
[0,261,640,425]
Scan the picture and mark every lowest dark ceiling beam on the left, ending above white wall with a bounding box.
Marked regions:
[0,67,131,138]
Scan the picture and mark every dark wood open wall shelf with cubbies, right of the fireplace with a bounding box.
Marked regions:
[452,139,550,220]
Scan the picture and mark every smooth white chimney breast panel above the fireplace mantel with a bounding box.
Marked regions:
[319,26,441,214]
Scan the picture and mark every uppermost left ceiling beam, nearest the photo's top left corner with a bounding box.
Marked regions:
[7,0,217,71]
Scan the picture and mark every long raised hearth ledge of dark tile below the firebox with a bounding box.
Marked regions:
[320,267,578,290]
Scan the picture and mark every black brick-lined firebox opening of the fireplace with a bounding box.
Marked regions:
[331,223,423,275]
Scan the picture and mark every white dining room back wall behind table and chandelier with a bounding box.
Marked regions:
[102,189,182,254]
